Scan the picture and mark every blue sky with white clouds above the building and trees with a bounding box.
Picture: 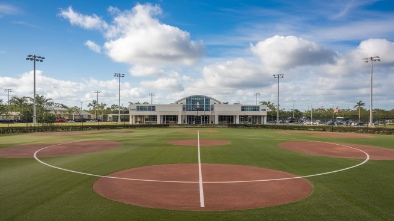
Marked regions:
[0,0,394,111]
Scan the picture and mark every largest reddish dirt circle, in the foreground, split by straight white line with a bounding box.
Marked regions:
[93,164,313,211]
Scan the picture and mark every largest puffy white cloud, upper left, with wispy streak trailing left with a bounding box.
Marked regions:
[60,4,204,69]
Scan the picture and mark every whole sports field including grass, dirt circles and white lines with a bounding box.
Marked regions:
[0,128,394,221]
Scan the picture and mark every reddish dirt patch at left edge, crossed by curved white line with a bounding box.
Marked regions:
[0,140,122,158]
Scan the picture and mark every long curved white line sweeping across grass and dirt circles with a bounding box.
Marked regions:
[34,141,370,184]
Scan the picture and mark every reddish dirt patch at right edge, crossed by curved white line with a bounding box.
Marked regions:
[279,141,394,160]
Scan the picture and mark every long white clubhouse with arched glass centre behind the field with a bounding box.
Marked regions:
[129,95,267,124]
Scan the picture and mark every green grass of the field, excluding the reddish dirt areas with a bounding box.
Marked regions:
[0,128,394,221]
